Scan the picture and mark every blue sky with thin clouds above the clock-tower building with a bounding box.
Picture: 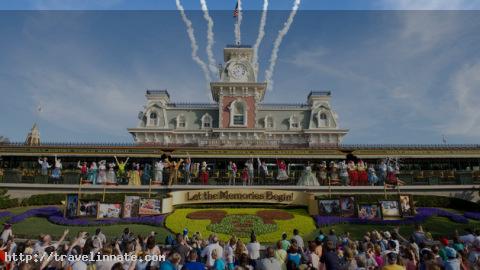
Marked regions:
[0,0,480,144]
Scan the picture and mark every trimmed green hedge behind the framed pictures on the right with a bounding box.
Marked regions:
[316,194,480,211]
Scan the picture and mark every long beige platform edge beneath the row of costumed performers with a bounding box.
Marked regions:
[0,183,480,202]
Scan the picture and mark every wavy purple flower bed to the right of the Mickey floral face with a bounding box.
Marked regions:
[315,207,468,226]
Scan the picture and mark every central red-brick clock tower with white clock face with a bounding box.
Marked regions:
[210,45,267,129]
